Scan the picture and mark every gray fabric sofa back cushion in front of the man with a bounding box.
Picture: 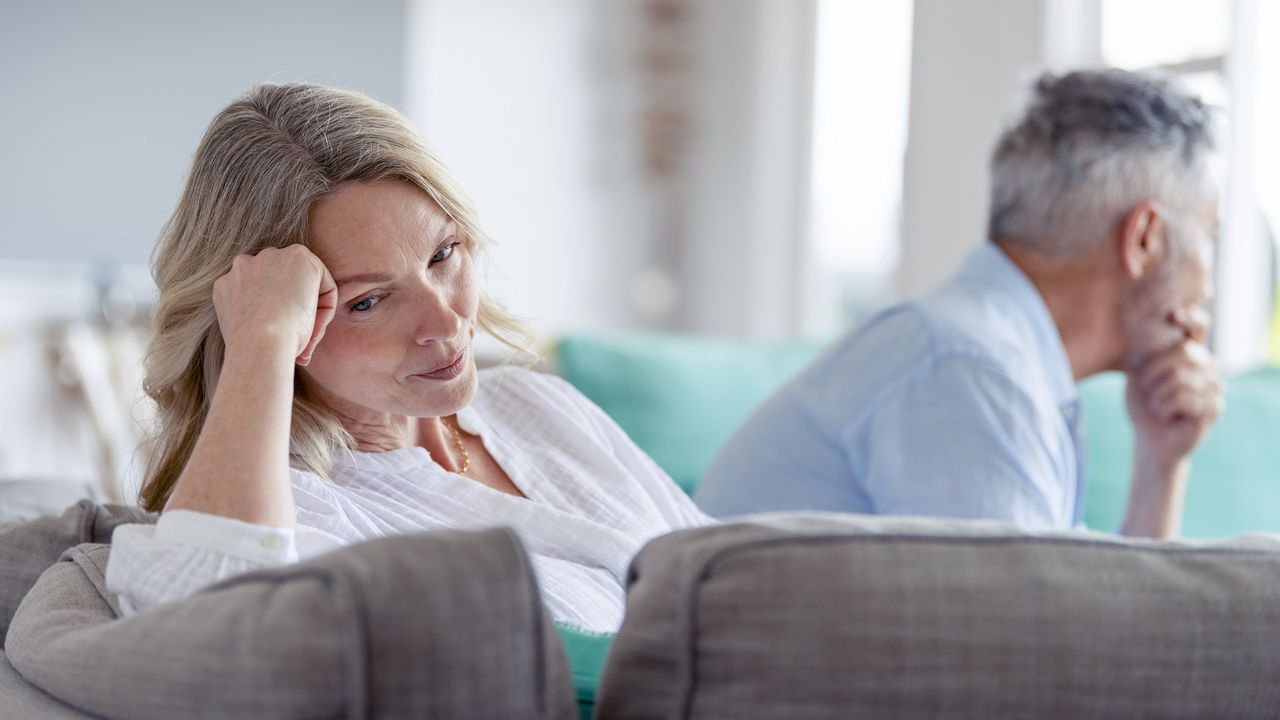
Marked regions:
[598,515,1280,720]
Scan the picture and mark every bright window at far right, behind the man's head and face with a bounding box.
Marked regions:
[1101,0,1280,368]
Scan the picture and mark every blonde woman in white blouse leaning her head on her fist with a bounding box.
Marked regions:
[108,85,709,632]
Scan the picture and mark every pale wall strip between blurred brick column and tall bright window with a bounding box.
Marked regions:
[680,0,817,340]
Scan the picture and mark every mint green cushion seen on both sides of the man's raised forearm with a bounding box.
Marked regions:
[1080,368,1280,538]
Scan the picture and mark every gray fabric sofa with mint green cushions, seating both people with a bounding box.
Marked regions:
[0,334,1280,719]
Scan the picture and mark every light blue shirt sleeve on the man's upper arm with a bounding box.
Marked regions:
[864,357,1075,528]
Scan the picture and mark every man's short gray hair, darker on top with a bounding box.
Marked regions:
[987,69,1213,256]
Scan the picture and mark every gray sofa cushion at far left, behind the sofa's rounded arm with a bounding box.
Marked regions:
[0,500,152,647]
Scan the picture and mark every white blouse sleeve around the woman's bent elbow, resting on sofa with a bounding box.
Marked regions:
[106,510,298,616]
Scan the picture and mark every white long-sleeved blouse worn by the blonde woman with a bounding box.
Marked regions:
[106,368,714,632]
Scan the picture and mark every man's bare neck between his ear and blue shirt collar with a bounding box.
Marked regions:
[998,242,1117,380]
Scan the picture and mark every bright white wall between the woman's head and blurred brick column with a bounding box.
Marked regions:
[407,0,645,337]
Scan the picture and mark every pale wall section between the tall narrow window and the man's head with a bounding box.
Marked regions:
[897,0,1098,296]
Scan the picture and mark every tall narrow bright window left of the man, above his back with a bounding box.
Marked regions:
[801,0,911,336]
